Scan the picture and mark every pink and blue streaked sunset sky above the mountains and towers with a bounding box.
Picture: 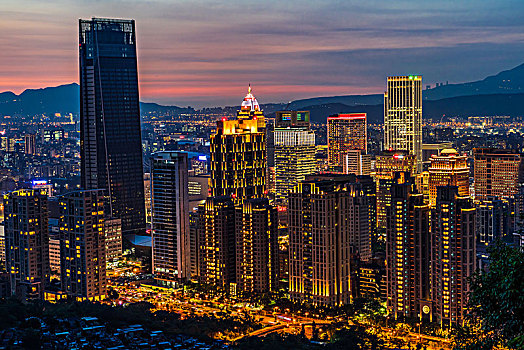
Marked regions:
[0,0,524,107]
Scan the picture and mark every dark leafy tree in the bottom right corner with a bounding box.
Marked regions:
[455,241,524,349]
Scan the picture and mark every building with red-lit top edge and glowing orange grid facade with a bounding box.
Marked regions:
[327,113,368,167]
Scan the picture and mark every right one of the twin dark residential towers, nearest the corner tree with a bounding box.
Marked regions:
[431,186,476,326]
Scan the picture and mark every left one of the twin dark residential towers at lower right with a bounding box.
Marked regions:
[386,173,431,318]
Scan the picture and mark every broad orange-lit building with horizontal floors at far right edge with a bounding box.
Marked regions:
[473,148,524,200]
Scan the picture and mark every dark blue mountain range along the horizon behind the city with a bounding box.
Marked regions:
[0,64,524,123]
